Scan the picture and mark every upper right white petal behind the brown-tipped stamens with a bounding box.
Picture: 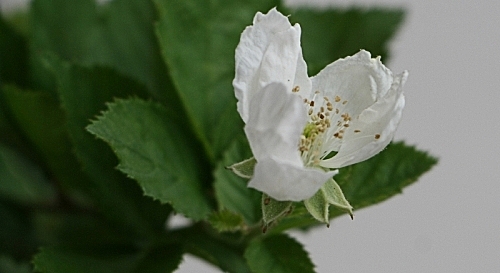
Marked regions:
[312,50,393,118]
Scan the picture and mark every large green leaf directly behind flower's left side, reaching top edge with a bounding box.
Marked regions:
[154,0,277,159]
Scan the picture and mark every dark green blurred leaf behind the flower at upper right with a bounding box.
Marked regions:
[289,8,404,75]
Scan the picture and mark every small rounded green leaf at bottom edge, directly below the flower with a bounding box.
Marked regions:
[245,234,315,273]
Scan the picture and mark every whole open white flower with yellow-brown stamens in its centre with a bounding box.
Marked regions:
[233,9,408,201]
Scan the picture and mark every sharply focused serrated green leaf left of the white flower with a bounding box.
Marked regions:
[87,99,211,220]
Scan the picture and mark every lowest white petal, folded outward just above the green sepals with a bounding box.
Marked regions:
[248,154,337,201]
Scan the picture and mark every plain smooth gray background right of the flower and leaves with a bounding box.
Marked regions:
[0,0,500,273]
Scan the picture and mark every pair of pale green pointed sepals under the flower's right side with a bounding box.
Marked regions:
[304,178,354,224]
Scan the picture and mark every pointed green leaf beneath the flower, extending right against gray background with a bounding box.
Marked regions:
[272,142,437,232]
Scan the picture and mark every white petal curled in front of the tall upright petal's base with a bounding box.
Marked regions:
[245,83,307,166]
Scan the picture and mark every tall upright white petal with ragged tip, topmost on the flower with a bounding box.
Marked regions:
[233,8,310,123]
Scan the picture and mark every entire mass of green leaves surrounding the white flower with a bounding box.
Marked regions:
[0,0,436,272]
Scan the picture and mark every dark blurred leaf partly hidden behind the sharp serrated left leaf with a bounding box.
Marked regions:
[45,55,168,235]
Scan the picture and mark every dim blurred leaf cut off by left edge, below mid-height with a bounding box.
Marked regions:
[0,145,56,204]
